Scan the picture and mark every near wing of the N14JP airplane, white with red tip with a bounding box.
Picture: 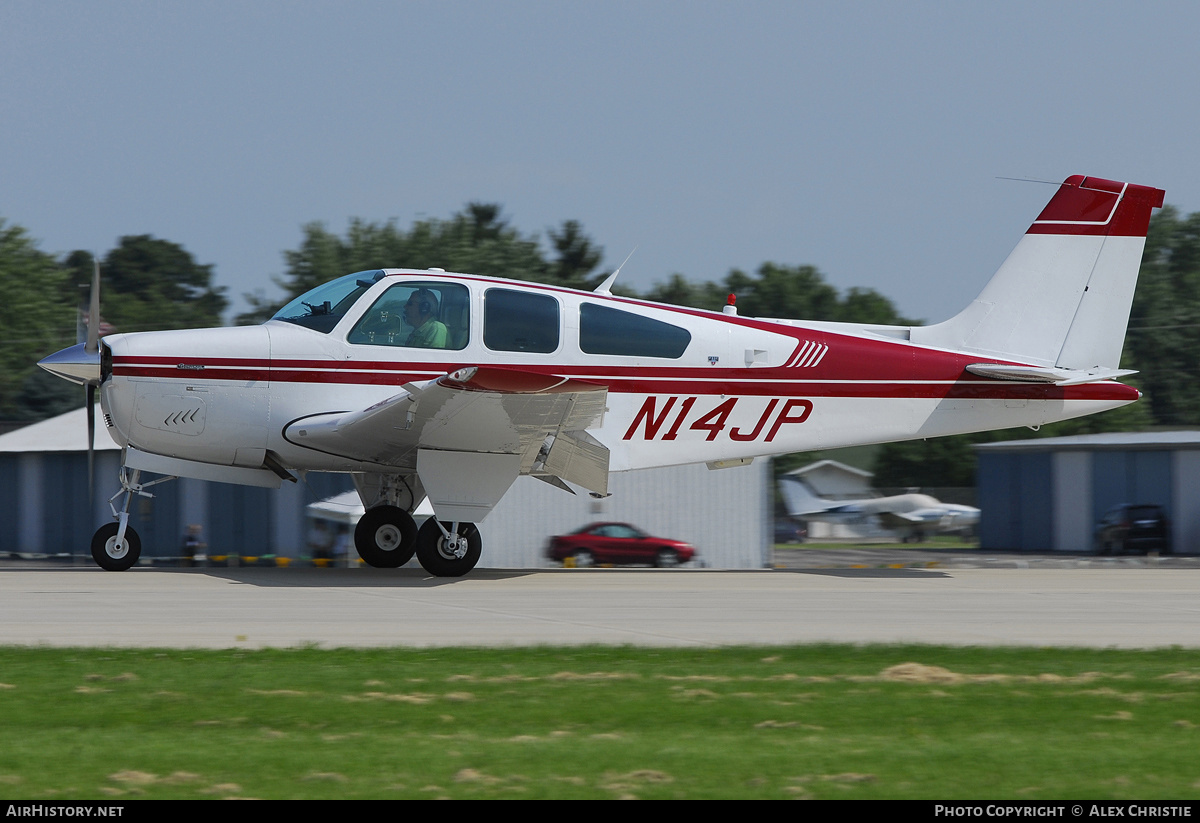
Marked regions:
[286,366,608,496]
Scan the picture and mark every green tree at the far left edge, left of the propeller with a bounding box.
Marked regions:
[0,220,76,420]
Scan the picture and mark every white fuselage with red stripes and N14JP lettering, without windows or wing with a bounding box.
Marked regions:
[102,271,1138,471]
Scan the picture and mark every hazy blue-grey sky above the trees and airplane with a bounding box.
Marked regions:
[0,0,1200,320]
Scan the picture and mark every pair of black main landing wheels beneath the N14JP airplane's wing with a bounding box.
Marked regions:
[354,505,482,577]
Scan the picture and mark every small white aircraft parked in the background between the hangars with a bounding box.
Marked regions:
[779,474,979,541]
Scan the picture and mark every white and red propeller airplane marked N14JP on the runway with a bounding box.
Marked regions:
[40,176,1164,576]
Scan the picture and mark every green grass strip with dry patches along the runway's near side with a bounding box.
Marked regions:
[0,645,1200,800]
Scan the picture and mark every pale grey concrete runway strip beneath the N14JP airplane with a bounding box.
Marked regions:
[0,555,1200,648]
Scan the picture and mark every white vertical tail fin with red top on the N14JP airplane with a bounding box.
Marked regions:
[911,175,1164,368]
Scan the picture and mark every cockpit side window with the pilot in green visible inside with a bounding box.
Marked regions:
[347,281,470,352]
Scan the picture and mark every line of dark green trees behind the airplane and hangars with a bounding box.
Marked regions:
[0,203,1200,486]
